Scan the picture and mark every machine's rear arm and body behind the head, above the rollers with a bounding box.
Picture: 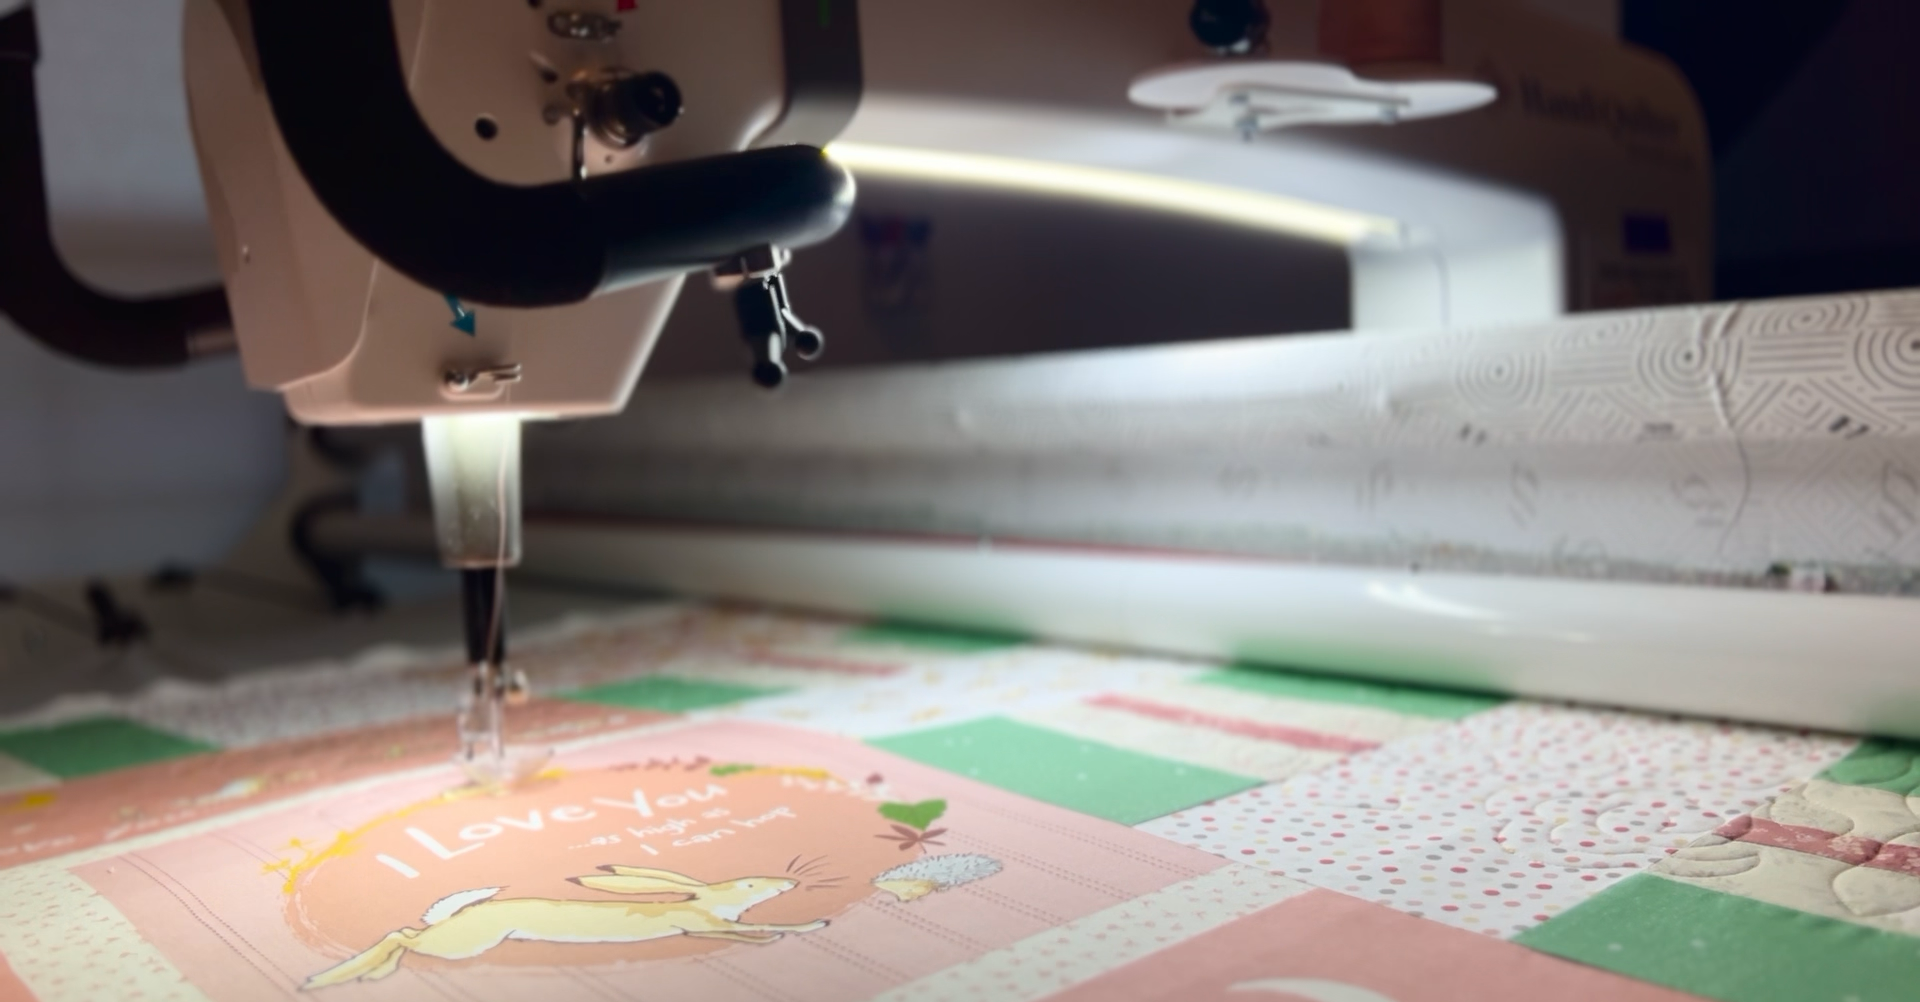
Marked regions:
[843,0,1713,332]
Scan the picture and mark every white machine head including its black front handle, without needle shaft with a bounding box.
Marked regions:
[186,0,852,424]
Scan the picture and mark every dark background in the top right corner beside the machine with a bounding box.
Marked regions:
[1620,0,1920,299]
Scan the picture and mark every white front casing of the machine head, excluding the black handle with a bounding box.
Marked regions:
[186,0,785,424]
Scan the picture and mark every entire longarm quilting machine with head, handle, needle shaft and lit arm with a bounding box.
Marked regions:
[165,0,1707,775]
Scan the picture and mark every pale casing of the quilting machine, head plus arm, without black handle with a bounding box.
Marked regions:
[186,0,1711,424]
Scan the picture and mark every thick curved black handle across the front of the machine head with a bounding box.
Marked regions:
[248,0,852,307]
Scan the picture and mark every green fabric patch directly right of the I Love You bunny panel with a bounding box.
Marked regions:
[872,716,1261,825]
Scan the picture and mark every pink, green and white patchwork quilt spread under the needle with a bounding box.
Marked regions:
[0,603,1920,1002]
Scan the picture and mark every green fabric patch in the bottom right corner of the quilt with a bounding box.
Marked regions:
[1515,873,1920,1002]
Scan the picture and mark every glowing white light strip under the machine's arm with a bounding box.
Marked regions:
[828,142,1400,246]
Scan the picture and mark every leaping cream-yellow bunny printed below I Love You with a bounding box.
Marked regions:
[301,866,828,990]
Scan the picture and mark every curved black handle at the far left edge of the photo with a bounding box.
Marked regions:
[0,4,232,369]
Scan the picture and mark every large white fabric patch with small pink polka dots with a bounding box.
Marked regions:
[1140,703,1857,937]
